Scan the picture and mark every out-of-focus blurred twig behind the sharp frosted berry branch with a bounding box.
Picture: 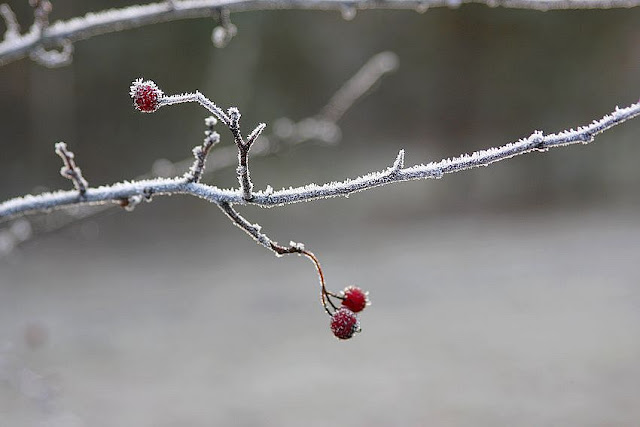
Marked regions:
[0,52,397,257]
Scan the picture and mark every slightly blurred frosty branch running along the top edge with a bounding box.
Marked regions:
[0,0,640,66]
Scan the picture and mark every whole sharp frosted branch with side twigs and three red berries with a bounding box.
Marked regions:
[0,65,640,339]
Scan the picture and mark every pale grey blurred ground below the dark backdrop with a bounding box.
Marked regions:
[0,201,640,427]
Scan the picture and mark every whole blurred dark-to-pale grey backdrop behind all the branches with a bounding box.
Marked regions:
[0,0,640,427]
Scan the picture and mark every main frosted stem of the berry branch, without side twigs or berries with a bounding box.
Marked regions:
[0,102,640,220]
